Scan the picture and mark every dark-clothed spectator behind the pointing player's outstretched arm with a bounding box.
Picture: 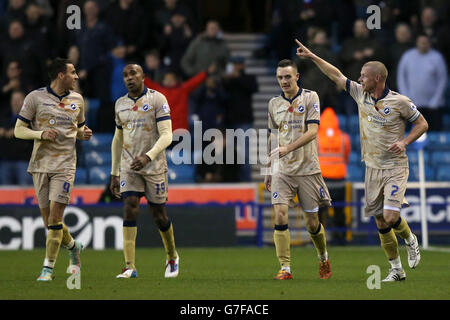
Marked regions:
[295,28,341,113]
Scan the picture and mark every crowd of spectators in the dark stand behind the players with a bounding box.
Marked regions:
[0,0,450,185]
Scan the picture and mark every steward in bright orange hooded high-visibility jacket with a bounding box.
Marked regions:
[317,108,351,180]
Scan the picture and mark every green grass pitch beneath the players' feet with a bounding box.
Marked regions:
[0,246,450,300]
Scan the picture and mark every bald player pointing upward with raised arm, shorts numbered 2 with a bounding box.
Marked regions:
[295,40,428,282]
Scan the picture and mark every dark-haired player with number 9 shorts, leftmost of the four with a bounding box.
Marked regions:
[14,58,92,281]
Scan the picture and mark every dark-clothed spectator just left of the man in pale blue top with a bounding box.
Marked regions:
[387,23,414,91]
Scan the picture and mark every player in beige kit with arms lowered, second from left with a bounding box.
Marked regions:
[110,64,179,278]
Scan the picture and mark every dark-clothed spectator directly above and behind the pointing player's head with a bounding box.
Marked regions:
[339,19,385,115]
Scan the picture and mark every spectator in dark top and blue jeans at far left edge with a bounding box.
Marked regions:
[0,91,33,186]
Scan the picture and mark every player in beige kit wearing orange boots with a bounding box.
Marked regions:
[264,59,331,280]
